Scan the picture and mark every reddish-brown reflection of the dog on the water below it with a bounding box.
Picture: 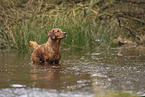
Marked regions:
[30,64,62,89]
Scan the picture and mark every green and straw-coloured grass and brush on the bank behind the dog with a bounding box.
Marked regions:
[0,0,145,51]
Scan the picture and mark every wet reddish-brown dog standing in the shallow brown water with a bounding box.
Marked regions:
[29,28,67,64]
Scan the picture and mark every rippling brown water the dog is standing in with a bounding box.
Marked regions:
[0,49,145,97]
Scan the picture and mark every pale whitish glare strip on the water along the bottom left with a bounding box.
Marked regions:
[0,88,93,97]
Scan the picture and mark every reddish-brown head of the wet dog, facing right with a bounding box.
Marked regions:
[48,28,67,40]
